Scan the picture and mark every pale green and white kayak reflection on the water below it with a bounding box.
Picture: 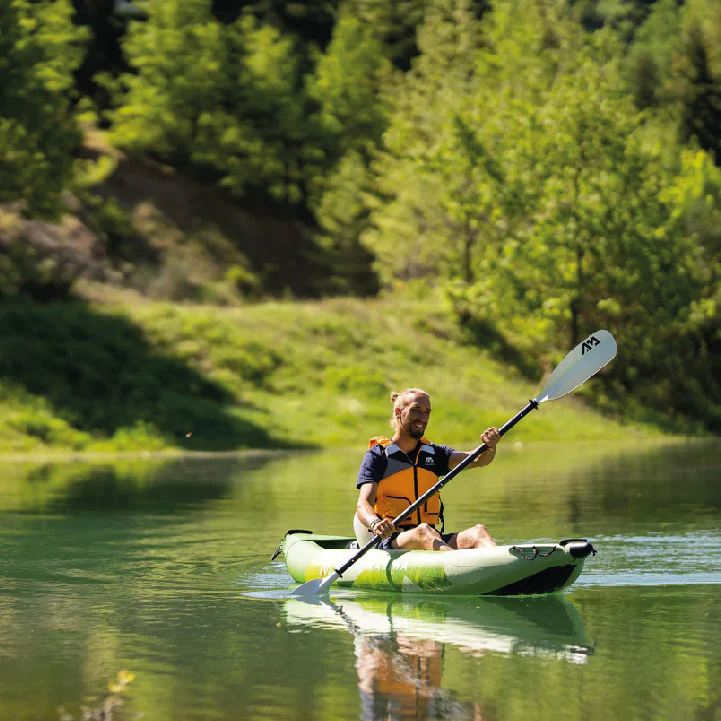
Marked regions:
[285,596,591,663]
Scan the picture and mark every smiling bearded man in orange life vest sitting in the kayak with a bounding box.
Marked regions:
[354,388,501,551]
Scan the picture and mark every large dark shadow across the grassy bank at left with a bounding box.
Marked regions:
[0,303,294,450]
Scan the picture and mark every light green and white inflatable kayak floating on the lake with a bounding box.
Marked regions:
[278,530,596,596]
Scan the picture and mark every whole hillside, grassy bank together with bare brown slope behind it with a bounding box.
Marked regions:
[0,136,664,453]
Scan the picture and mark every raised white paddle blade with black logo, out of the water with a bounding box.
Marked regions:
[536,330,617,403]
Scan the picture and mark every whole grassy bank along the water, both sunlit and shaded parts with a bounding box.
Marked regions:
[0,292,656,453]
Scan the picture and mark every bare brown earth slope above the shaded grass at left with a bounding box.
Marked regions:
[0,131,329,305]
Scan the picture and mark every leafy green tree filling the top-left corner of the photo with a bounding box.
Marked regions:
[0,0,83,216]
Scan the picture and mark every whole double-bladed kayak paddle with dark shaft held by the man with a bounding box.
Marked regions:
[291,330,616,596]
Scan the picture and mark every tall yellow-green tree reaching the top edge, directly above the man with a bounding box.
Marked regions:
[362,0,490,283]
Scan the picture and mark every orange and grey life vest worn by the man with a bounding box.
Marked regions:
[368,436,443,528]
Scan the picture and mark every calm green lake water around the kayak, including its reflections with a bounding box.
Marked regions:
[0,441,721,721]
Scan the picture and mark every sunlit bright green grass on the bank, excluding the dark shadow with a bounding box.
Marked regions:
[0,298,657,453]
